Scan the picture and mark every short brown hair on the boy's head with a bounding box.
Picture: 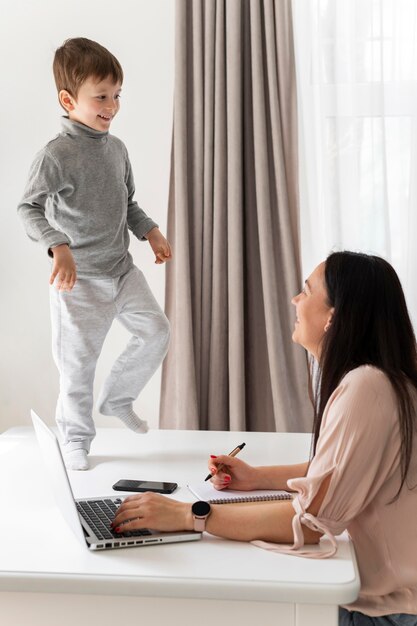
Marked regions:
[53,37,123,98]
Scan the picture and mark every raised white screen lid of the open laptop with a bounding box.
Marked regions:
[30,410,86,546]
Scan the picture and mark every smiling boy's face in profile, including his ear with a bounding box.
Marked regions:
[59,77,122,131]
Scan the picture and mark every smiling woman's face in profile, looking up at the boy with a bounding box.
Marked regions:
[291,262,334,359]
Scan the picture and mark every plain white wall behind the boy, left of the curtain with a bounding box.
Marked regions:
[0,0,174,432]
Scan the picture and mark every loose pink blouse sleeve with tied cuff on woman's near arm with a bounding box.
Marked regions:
[250,366,401,558]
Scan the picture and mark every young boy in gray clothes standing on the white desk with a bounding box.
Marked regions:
[18,38,171,470]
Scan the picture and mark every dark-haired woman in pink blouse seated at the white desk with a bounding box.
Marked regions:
[114,252,417,626]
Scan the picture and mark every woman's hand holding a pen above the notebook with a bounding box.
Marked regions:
[208,454,260,491]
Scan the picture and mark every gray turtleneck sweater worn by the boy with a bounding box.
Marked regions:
[18,117,157,278]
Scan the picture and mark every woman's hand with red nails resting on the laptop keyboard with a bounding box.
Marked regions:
[112,492,194,533]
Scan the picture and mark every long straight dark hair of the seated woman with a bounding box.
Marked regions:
[313,252,417,496]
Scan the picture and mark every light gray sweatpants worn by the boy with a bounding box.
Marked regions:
[50,267,169,451]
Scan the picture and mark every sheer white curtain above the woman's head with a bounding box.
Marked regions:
[293,0,417,326]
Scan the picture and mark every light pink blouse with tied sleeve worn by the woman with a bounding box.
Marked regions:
[254,365,417,616]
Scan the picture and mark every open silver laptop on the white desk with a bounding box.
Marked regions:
[30,411,202,550]
